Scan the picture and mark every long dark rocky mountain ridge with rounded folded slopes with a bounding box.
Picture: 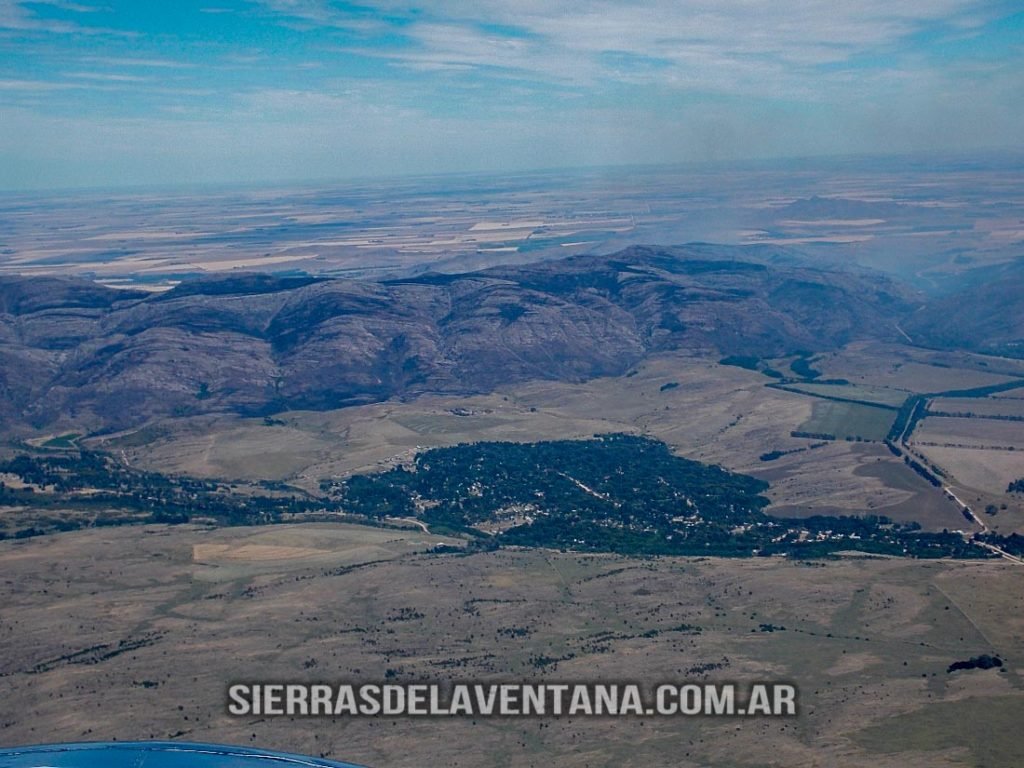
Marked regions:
[0,246,912,430]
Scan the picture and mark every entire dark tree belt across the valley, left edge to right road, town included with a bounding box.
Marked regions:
[0,434,1003,558]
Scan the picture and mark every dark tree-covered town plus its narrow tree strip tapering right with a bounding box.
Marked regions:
[339,434,990,557]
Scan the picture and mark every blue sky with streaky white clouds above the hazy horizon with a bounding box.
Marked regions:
[0,0,1024,190]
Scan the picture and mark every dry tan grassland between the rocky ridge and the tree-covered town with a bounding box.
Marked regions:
[83,350,1024,529]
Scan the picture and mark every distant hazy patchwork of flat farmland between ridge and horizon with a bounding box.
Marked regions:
[0,159,1022,290]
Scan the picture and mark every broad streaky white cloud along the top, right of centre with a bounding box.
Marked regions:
[247,0,1007,98]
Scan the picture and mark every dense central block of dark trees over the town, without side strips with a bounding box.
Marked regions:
[331,434,768,532]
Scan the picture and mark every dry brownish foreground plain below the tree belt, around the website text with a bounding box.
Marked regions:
[0,525,1024,768]
